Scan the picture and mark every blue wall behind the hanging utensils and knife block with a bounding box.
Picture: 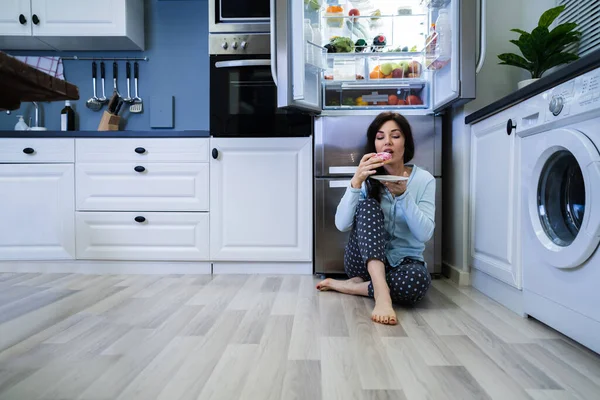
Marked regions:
[0,0,209,130]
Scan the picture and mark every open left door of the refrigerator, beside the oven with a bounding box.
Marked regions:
[271,0,327,113]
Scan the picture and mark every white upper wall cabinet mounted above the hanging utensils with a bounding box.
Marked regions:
[0,0,145,51]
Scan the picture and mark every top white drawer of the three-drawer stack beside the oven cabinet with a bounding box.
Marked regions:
[76,138,209,162]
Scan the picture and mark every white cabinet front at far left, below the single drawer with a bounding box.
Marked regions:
[0,164,75,260]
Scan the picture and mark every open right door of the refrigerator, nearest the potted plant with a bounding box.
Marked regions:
[430,0,477,112]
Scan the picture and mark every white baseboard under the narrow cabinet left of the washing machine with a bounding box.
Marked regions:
[471,268,526,317]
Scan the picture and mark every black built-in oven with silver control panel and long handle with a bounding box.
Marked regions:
[209,34,312,137]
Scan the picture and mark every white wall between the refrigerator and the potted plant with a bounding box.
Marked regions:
[442,0,556,278]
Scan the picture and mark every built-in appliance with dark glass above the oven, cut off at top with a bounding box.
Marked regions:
[208,0,271,33]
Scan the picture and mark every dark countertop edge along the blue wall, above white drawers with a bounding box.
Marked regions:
[0,130,210,138]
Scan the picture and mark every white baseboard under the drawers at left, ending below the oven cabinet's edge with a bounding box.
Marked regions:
[0,260,211,275]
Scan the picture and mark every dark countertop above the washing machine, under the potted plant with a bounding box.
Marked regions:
[465,50,600,124]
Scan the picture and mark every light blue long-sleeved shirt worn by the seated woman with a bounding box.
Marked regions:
[335,164,435,267]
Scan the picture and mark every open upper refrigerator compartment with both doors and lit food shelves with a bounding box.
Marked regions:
[271,0,477,114]
